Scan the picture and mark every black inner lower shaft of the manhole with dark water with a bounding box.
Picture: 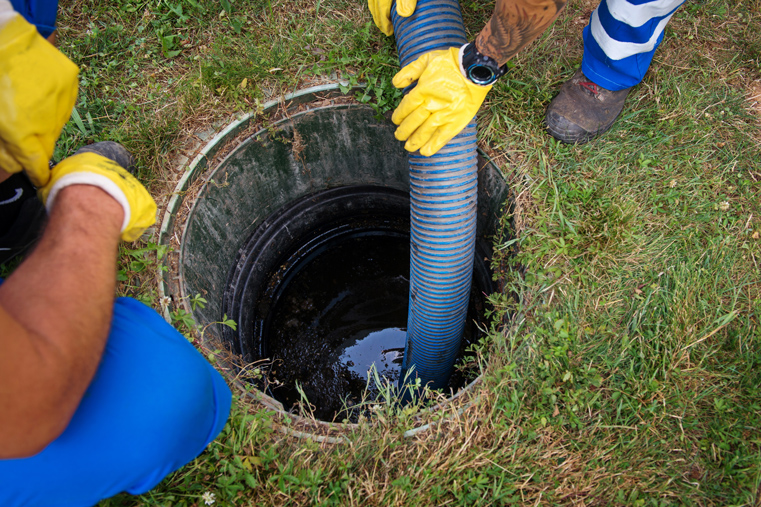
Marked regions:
[223,186,493,422]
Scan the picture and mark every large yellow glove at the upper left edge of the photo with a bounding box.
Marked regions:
[0,14,79,187]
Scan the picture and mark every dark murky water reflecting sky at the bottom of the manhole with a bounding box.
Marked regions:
[264,231,473,421]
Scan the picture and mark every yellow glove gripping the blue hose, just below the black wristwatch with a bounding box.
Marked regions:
[391,48,491,157]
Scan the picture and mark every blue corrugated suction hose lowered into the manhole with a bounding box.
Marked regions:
[391,0,478,389]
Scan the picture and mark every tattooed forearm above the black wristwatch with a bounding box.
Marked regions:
[476,0,566,65]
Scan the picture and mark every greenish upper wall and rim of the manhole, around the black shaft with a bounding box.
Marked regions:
[159,83,508,442]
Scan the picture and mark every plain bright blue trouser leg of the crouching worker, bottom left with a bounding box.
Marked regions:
[0,298,232,507]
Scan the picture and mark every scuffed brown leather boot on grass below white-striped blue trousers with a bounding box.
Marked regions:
[544,69,631,144]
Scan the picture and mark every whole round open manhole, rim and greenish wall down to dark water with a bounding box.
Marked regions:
[159,85,510,432]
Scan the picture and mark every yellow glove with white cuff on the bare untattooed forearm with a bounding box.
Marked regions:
[39,153,156,241]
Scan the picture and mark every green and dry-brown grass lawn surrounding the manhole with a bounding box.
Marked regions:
[49,0,761,507]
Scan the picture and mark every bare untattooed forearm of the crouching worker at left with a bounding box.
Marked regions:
[0,185,123,457]
